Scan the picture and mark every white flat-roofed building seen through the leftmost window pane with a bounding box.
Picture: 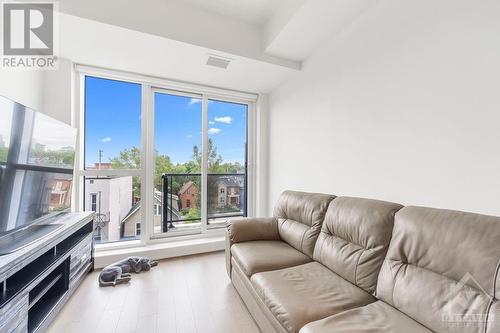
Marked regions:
[85,176,133,241]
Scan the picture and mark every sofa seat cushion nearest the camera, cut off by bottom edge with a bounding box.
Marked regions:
[300,301,432,333]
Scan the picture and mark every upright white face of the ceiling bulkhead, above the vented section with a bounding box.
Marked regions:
[59,0,303,69]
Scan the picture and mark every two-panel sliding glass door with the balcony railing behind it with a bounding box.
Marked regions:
[153,90,248,236]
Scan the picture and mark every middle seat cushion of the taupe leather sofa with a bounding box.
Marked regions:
[251,262,375,333]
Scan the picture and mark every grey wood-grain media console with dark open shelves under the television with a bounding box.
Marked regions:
[0,212,94,333]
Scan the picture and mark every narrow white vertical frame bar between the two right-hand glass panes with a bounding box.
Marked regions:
[201,95,208,233]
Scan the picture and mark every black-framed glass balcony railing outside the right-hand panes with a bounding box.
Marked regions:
[162,173,247,232]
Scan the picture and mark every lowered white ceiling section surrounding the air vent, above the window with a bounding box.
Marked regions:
[59,14,295,93]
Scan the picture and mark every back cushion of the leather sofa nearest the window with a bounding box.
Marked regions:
[274,191,335,258]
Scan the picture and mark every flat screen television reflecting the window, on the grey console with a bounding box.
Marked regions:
[0,96,76,250]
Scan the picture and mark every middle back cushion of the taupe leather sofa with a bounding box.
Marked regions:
[313,197,402,293]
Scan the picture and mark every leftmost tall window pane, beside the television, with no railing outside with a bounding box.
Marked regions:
[83,76,142,242]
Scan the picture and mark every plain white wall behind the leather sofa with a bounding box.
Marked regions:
[269,0,500,215]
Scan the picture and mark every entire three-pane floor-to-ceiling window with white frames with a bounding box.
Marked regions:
[78,67,258,243]
